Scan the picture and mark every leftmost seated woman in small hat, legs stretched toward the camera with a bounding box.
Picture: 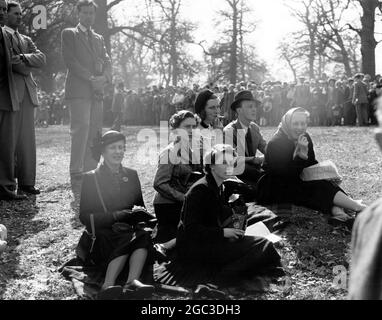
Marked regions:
[80,131,154,300]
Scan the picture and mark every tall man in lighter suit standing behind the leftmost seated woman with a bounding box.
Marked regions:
[61,0,111,180]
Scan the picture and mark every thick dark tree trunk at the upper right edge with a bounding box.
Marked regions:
[359,0,379,78]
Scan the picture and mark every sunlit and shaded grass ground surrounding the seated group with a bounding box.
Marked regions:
[0,126,382,300]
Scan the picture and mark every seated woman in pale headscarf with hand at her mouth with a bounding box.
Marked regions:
[258,108,365,222]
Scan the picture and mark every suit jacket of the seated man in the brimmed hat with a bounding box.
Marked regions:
[224,120,267,157]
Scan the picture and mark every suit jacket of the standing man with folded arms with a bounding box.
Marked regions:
[5,30,46,107]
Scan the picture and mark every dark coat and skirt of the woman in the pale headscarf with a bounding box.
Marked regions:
[258,130,342,214]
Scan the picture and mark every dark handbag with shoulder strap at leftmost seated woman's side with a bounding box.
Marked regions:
[76,171,103,264]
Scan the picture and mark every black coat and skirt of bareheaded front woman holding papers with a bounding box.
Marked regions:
[176,174,280,281]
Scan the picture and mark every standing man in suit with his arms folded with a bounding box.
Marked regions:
[5,1,46,195]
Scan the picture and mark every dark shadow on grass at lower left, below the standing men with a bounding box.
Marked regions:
[0,197,49,300]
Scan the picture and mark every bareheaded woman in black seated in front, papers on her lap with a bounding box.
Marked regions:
[176,145,280,285]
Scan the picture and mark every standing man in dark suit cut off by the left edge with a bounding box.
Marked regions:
[0,0,26,201]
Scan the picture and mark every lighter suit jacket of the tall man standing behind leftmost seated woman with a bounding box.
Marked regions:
[61,26,112,99]
